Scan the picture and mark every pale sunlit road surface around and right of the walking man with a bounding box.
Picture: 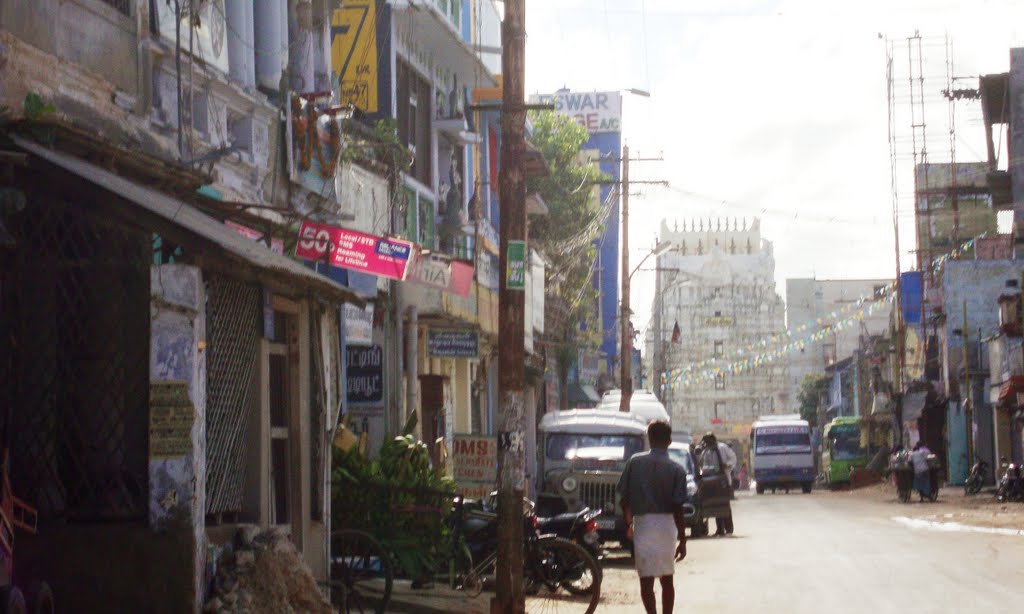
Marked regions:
[598,493,1024,614]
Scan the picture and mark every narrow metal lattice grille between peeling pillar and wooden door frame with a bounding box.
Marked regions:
[206,275,260,514]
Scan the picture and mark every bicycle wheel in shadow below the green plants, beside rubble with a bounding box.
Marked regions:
[331,529,393,614]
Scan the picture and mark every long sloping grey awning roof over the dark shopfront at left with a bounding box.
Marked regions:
[12,136,366,306]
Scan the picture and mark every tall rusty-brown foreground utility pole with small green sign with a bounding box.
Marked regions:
[490,0,528,614]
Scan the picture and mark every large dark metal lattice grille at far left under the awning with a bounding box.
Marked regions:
[0,195,150,521]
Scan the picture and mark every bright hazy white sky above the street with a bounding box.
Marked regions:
[526,0,1024,335]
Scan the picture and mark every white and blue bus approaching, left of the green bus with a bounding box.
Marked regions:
[751,413,816,494]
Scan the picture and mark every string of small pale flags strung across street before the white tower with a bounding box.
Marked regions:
[664,232,987,389]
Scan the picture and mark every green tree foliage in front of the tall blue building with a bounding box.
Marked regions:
[526,112,607,401]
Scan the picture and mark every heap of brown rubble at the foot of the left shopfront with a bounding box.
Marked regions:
[203,527,334,614]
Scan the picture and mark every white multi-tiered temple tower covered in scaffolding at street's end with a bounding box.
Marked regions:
[649,218,792,432]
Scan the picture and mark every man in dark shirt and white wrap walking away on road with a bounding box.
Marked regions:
[617,421,687,614]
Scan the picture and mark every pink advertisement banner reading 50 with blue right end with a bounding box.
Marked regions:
[295,221,413,280]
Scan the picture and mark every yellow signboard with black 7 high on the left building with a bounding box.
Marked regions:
[331,0,377,113]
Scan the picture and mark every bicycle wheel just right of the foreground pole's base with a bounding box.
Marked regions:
[526,537,602,614]
